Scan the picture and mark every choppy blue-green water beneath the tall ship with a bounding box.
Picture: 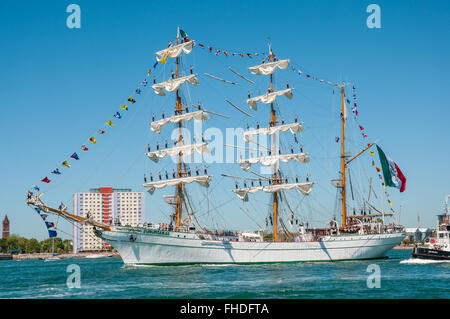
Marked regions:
[0,250,450,299]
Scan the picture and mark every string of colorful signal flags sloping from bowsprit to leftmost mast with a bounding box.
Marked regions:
[29,61,162,192]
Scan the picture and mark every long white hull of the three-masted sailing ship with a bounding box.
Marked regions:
[101,230,405,265]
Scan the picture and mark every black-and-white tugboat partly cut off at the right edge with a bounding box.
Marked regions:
[411,195,450,260]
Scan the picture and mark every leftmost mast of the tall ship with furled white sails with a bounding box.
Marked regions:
[142,27,208,231]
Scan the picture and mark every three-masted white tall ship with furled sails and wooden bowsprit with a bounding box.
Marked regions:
[27,29,405,265]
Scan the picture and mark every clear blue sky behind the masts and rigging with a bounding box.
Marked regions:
[0,0,450,239]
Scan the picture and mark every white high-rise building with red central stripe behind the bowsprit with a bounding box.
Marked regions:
[73,187,145,253]
